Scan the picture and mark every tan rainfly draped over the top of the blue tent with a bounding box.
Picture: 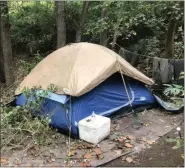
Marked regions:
[16,42,154,96]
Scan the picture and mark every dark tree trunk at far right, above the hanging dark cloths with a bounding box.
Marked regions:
[165,13,176,58]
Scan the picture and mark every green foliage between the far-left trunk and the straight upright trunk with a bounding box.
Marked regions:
[9,2,56,55]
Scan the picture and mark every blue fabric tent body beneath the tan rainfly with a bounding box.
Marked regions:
[16,74,156,136]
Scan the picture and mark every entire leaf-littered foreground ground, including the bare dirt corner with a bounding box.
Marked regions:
[0,109,184,167]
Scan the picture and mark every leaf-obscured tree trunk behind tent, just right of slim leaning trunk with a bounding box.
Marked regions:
[100,7,108,46]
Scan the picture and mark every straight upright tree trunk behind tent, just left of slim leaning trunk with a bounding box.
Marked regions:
[55,1,66,48]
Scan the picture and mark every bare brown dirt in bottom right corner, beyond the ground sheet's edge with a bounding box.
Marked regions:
[101,123,184,167]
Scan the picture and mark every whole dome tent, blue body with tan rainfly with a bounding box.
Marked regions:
[16,43,156,136]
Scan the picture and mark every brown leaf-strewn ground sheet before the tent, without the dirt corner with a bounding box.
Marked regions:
[2,109,183,166]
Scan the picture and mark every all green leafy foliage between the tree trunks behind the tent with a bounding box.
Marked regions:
[9,1,184,58]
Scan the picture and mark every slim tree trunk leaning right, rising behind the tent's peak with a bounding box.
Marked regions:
[76,1,90,42]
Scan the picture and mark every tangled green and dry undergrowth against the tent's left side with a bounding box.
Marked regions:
[0,87,65,153]
